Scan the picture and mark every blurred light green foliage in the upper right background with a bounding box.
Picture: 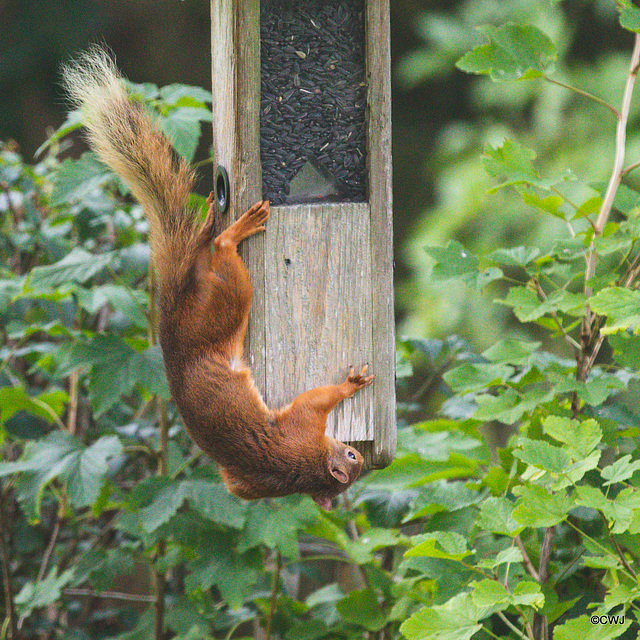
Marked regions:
[397,0,640,349]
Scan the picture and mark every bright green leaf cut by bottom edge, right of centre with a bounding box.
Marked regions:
[400,593,484,640]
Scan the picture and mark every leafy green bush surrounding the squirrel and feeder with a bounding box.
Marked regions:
[0,5,640,640]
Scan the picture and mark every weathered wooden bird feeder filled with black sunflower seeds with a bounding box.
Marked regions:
[211,0,396,468]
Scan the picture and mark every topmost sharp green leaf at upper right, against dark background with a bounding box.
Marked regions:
[456,23,557,80]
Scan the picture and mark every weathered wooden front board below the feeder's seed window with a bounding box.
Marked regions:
[264,203,375,441]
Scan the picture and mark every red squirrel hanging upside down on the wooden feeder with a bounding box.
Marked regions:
[64,47,373,509]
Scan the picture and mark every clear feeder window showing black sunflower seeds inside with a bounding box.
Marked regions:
[260,0,367,205]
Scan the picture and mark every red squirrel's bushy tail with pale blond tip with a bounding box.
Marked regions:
[63,46,196,293]
